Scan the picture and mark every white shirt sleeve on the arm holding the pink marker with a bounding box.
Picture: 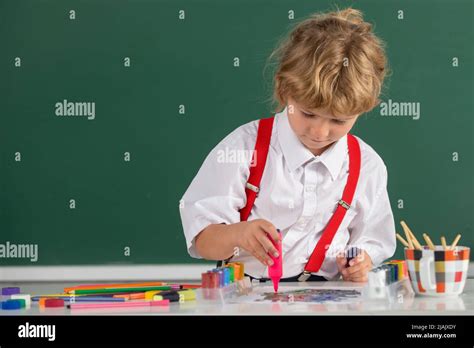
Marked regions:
[179,132,252,258]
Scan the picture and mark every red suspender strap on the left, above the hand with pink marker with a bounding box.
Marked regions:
[240,117,274,221]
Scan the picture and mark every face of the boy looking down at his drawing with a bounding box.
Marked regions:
[288,98,359,156]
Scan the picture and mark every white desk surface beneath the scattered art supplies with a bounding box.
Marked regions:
[0,279,474,315]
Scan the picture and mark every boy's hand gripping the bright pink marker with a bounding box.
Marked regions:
[237,219,280,266]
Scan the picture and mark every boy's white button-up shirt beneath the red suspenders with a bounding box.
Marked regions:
[180,108,396,279]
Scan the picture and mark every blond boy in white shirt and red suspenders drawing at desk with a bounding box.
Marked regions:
[180,9,396,282]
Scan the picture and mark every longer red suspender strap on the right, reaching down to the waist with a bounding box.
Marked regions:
[303,134,360,275]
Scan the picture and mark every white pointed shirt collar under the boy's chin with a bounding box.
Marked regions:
[276,107,348,181]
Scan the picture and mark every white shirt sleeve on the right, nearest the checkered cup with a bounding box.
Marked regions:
[349,165,396,267]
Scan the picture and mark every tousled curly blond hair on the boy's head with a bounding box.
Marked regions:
[269,8,388,116]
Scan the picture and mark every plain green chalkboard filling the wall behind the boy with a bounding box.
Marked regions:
[0,0,474,265]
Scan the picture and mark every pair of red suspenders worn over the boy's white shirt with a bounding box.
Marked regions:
[240,117,360,281]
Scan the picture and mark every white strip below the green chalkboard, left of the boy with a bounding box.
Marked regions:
[0,263,216,282]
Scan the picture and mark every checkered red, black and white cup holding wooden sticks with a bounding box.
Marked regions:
[405,246,470,296]
